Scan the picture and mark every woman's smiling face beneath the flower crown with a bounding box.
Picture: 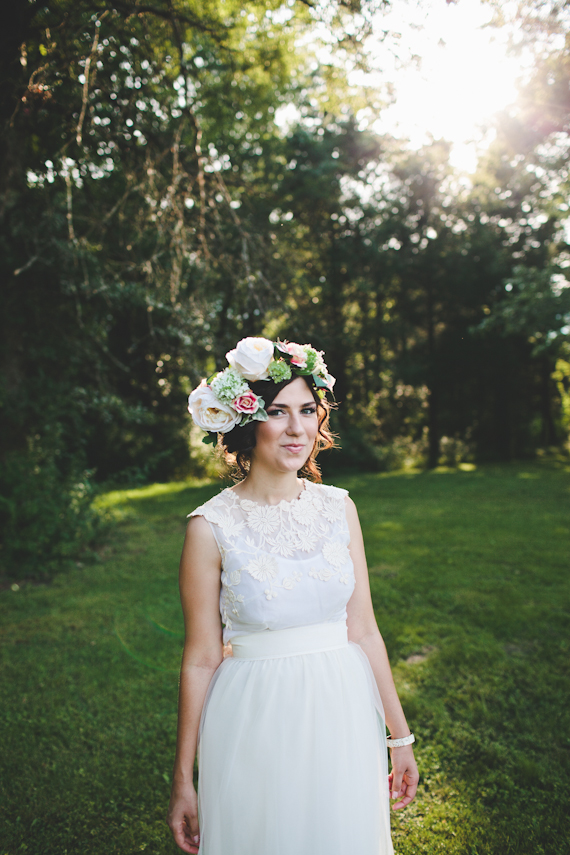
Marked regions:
[252,377,319,472]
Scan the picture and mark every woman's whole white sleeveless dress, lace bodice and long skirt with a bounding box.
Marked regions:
[189,481,393,855]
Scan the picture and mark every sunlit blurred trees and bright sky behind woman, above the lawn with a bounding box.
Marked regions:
[0,0,570,579]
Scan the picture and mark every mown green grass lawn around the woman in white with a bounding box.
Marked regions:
[0,464,570,855]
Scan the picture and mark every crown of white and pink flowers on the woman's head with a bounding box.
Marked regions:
[188,336,335,442]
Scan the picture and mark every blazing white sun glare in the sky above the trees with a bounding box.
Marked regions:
[364,0,523,172]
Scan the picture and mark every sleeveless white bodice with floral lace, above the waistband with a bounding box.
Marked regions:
[189,481,354,643]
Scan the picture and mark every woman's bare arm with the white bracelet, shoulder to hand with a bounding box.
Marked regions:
[346,497,419,810]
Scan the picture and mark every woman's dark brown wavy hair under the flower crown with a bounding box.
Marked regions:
[218,376,335,483]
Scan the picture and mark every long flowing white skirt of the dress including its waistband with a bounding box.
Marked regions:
[198,624,393,855]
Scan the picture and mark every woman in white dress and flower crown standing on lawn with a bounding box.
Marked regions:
[168,338,418,855]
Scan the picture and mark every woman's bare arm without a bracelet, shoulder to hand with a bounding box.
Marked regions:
[168,517,222,853]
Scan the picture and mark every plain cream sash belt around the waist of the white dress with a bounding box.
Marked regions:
[231,623,348,659]
